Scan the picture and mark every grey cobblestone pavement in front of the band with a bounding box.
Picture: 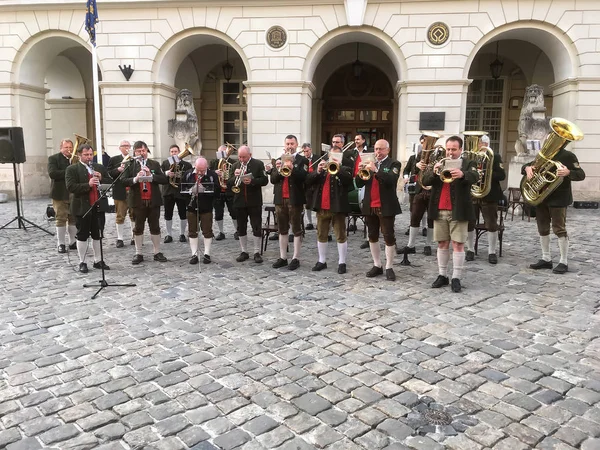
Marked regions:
[0,200,600,450]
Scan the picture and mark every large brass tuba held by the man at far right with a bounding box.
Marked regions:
[521,117,583,206]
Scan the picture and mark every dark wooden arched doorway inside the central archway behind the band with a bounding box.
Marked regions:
[321,64,395,149]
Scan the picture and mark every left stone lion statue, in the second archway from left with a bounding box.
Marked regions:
[168,89,202,154]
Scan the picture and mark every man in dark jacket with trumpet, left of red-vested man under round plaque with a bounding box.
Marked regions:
[227,145,269,263]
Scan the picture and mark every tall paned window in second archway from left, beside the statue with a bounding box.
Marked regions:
[221,81,248,147]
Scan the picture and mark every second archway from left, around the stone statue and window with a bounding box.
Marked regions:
[155,29,249,158]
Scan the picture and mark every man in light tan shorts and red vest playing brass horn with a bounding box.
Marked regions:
[422,136,479,292]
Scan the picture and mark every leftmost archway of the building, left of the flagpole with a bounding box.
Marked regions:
[13,31,102,196]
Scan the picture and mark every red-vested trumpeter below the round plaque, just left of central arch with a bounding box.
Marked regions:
[270,134,308,270]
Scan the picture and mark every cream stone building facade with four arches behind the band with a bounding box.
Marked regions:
[0,0,600,199]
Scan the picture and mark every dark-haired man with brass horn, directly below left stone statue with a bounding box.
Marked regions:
[161,144,192,244]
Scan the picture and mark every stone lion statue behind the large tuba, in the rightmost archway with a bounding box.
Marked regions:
[515,84,550,157]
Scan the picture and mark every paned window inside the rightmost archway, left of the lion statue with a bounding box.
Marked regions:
[465,78,504,151]
